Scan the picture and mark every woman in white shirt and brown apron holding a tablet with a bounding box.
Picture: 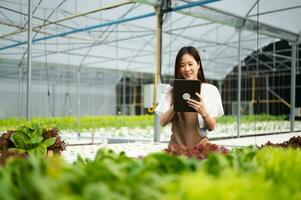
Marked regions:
[156,46,224,148]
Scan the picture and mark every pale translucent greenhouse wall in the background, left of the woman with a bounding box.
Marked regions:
[0,59,121,118]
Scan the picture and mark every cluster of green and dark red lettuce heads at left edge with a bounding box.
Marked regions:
[0,121,67,162]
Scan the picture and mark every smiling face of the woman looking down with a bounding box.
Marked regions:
[180,54,200,80]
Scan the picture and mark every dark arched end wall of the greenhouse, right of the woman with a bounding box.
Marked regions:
[221,41,301,116]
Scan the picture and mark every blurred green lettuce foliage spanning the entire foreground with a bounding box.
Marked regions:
[0,147,301,200]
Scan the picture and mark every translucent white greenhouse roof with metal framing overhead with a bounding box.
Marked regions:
[0,0,301,80]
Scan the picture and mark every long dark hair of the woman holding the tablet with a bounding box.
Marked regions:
[175,46,206,83]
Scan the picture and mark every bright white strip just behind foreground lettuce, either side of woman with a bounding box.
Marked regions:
[61,132,301,163]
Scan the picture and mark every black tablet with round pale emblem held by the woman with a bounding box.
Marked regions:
[173,79,201,112]
